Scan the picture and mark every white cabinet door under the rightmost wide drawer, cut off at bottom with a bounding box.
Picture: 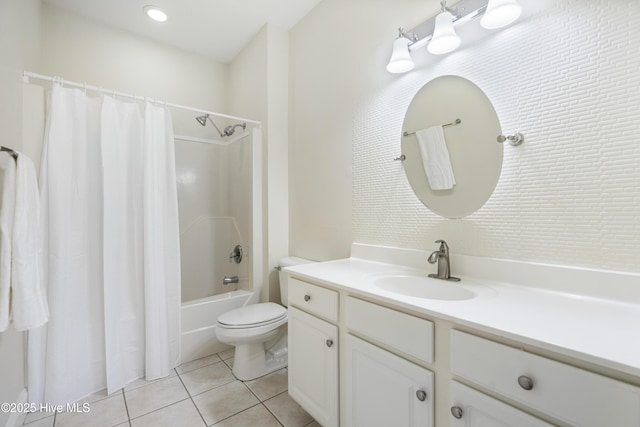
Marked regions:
[450,381,552,427]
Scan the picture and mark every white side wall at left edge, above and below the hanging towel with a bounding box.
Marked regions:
[0,0,40,426]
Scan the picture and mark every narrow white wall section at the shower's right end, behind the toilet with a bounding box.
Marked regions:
[229,24,289,301]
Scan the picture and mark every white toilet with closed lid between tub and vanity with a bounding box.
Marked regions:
[216,257,313,381]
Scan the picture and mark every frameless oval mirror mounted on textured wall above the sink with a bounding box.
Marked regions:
[401,76,502,218]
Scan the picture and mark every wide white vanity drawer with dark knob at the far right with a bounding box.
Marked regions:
[451,331,640,427]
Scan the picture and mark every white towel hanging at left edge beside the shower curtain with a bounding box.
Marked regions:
[0,153,49,332]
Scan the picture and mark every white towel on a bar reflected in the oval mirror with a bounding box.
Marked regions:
[416,126,456,190]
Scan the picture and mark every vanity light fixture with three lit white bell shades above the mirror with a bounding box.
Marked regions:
[387,0,522,73]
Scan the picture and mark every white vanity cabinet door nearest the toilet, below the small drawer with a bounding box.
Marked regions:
[289,307,338,427]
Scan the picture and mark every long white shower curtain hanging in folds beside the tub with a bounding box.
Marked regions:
[29,84,180,404]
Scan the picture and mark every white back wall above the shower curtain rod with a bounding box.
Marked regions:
[42,4,228,115]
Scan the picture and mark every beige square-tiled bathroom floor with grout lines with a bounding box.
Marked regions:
[24,350,320,427]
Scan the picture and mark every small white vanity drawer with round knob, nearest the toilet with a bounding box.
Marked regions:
[289,277,338,322]
